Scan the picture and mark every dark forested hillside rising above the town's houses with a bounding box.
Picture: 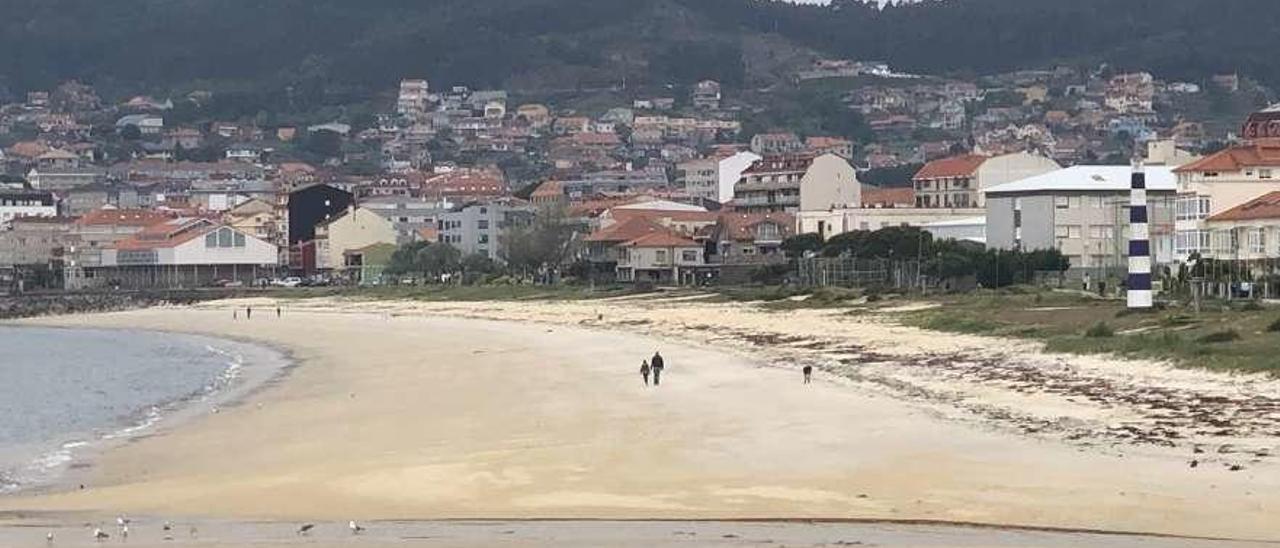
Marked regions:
[0,0,1280,93]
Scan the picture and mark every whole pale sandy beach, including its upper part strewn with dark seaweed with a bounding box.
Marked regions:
[0,298,1280,545]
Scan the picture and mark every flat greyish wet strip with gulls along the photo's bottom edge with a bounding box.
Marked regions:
[0,521,1275,548]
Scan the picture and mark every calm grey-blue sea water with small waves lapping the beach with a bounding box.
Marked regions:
[0,326,263,494]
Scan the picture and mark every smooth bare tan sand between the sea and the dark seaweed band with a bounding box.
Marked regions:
[0,301,1280,545]
